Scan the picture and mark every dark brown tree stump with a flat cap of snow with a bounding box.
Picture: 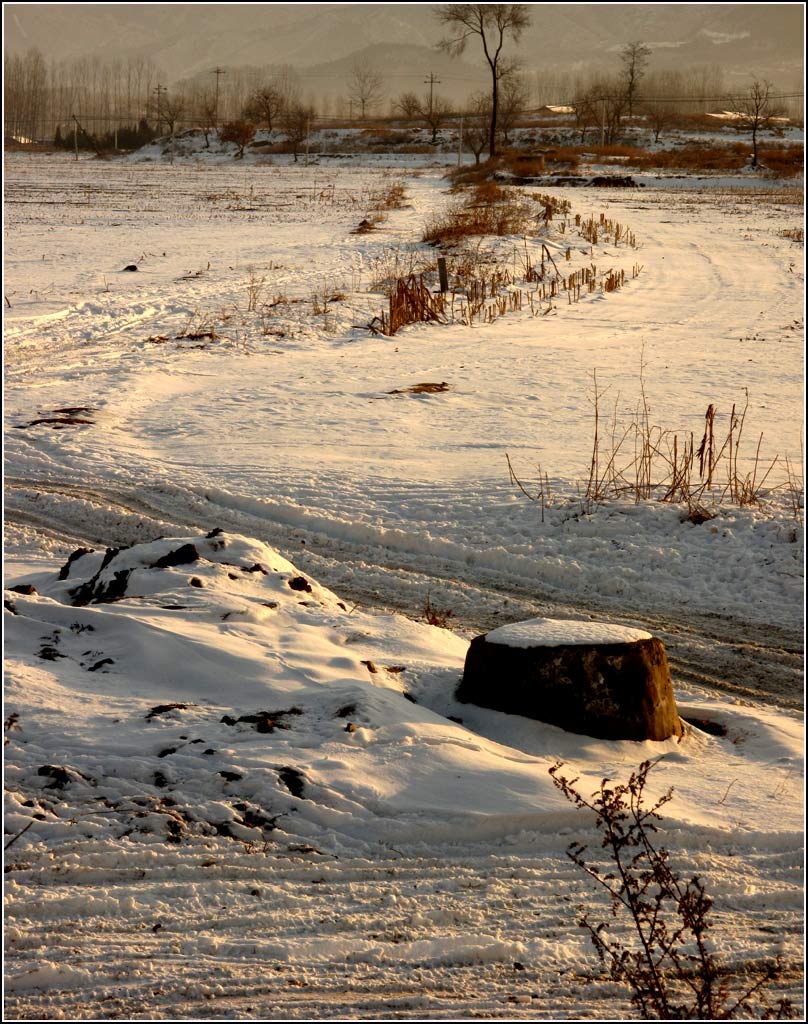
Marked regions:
[457,618,682,740]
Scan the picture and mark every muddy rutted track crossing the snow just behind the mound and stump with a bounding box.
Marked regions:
[6,477,803,709]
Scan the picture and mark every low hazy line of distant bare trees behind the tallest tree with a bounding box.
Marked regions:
[3,47,802,150]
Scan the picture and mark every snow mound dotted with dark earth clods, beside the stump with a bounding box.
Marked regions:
[5,529,802,856]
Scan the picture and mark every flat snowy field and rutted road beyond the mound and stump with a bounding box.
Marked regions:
[6,155,802,707]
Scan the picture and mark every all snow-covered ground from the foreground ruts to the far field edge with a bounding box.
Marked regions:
[5,149,804,1019]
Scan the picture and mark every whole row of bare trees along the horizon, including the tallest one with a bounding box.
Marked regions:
[4,3,798,160]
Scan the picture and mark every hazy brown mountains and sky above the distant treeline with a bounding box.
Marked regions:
[3,3,804,95]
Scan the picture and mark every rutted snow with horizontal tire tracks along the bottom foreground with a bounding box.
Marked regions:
[5,828,802,1020]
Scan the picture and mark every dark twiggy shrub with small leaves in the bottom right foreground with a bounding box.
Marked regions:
[550,758,792,1020]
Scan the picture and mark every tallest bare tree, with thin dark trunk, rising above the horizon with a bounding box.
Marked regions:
[437,3,530,158]
